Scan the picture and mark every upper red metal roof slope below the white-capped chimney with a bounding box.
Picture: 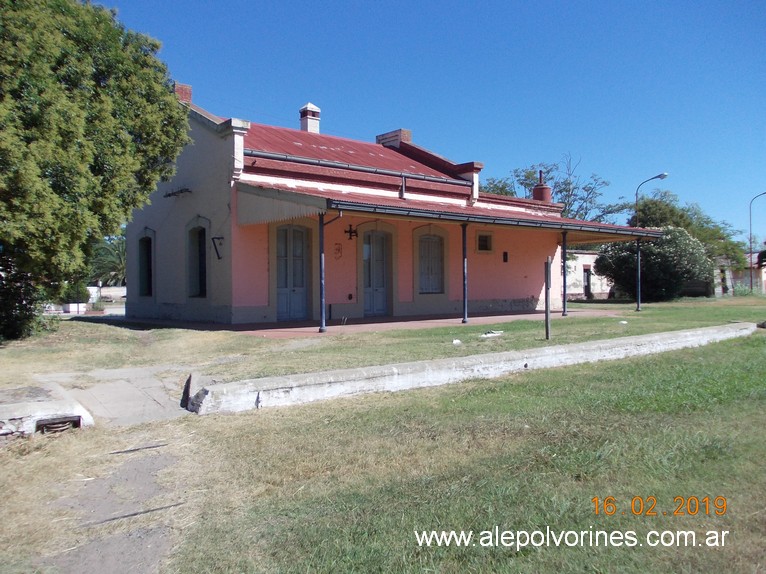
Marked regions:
[245,123,452,177]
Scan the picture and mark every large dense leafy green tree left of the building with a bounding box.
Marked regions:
[0,0,188,340]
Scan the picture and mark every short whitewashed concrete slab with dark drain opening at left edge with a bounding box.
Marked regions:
[0,383,93,436]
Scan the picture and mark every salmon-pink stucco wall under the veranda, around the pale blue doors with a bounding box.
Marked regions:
[232,215,560,316]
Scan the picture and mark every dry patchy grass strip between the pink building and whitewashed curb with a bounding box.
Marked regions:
[0,297,766,389]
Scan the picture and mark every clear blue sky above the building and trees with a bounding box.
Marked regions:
[111,0,766,245]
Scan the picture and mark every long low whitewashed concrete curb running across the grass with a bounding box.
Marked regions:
[187,323,756,415]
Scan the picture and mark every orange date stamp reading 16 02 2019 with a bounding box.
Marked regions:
[590,495,728,516]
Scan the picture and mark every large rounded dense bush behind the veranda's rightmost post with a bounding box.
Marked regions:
[595,227,713,301]
